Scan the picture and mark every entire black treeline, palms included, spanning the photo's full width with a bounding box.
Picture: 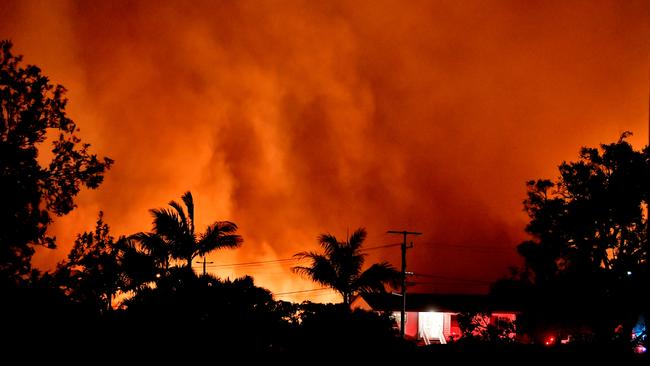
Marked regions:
[0,41,650,363]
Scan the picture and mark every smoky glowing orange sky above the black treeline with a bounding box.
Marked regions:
[0,0,650,300]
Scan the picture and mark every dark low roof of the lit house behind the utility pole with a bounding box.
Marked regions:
[361,293,518,313]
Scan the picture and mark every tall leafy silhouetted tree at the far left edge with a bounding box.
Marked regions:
[0,41,113,279]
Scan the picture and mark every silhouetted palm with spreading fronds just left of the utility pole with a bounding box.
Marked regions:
[292,228,400,305]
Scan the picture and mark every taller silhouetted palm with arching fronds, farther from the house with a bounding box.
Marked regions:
[151,191,243,269]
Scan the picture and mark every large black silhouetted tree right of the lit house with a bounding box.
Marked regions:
[512,132,650,346]
